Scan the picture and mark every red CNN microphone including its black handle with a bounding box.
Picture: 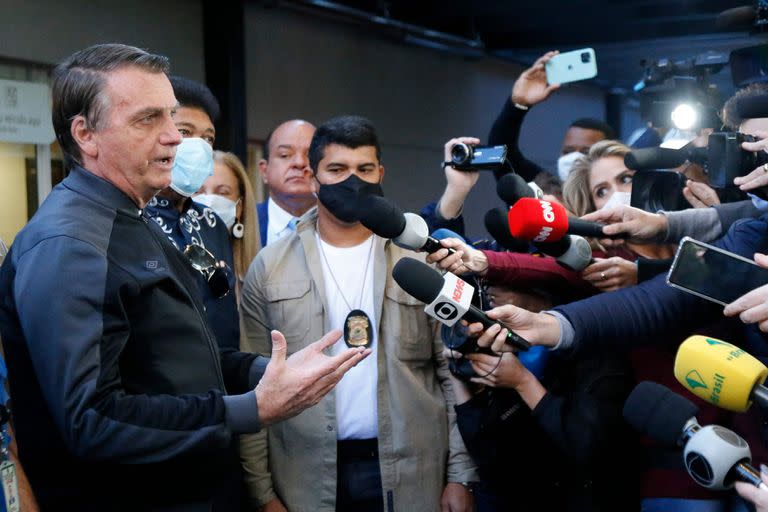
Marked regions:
[508,197,617,242]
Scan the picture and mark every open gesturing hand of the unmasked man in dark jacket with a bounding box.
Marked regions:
[255,330,371,426]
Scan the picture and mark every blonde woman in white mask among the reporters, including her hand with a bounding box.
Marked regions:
[563,140,674,291]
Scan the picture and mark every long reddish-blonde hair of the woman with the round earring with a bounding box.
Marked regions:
[213,151,259,280]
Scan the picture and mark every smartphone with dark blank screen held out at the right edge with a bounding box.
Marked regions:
[667,237,768,306]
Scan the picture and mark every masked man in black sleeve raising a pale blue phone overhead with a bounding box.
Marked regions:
[488,51,616,181]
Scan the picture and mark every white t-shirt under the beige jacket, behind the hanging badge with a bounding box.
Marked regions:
[317,235,383,440]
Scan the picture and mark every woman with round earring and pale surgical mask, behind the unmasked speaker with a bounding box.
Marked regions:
[192,151,259,296]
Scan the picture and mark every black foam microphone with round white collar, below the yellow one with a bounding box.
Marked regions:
[624,381,768,490]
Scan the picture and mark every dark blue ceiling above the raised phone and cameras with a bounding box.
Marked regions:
[280,0,768,94]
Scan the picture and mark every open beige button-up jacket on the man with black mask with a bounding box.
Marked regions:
[240,209,477,512]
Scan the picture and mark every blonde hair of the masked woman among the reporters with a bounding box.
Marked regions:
[563,140,631,217]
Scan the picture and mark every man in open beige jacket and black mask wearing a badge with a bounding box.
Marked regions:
[241,116,476,512]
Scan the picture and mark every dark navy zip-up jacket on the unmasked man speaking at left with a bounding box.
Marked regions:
[0,168,265,511]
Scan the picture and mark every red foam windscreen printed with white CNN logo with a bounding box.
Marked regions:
[507,197,568,242]
